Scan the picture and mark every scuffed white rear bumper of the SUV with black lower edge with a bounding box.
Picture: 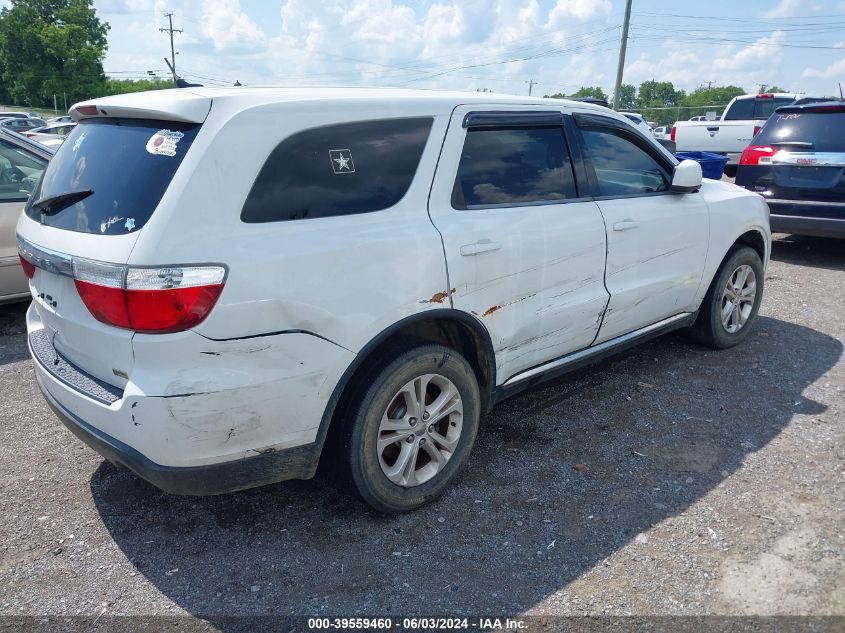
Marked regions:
[27,305,353,495]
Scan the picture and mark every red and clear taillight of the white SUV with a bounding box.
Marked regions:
[73,258,226,334]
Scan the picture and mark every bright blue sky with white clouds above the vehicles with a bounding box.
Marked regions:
[95,0,845,95]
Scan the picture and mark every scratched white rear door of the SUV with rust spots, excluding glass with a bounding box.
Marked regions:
[429,106,608,384]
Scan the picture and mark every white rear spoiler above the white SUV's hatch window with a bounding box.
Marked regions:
[69,89,211,123]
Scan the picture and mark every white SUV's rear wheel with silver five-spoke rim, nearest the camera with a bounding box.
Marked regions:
[340,345,481,514]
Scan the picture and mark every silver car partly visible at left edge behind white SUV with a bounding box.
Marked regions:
[0,128,53,303]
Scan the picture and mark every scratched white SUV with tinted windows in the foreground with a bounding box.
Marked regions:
[17,88,771,512]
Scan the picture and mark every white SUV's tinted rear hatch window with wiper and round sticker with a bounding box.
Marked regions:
[25,118,201,235]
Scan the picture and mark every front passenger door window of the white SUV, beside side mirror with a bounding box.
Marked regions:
[581,129,670,196]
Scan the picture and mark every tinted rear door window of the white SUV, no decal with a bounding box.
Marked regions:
[452,127,578,209]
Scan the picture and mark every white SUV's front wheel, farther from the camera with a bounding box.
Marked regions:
[690,246,764,349]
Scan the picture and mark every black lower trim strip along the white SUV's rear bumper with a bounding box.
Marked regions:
[39,381,319,496]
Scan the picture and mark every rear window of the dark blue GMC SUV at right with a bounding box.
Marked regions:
[754,111,845,152]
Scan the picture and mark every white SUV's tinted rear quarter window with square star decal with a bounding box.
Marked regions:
[241,117,433,222]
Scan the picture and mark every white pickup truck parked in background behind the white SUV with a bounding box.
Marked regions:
[670,93,801,175]
